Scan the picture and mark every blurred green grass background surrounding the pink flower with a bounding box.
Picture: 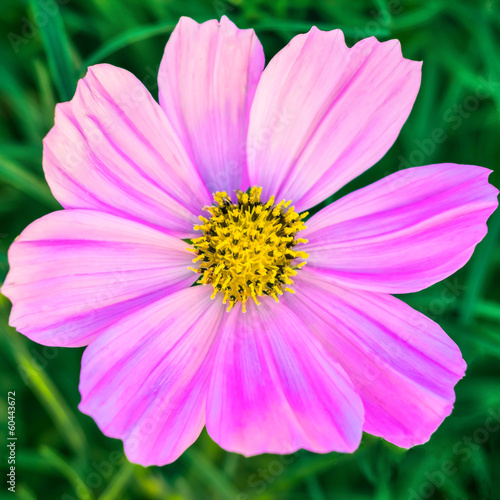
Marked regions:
[0,0,500,500]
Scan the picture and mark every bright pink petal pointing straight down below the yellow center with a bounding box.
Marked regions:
[207,297,363,456]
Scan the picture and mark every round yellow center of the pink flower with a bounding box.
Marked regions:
[189,187,308,312]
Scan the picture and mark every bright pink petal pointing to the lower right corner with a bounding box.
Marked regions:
[283,269,466,448]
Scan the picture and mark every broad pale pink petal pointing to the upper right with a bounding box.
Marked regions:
[248,27,421,211]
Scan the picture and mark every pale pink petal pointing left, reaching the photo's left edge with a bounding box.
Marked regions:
[2,210,194,347]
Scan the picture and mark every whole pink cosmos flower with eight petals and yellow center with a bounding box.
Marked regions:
[2,17,497,465]
